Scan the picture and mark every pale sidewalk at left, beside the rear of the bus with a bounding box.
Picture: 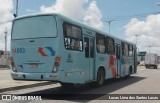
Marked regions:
[0,68,54,93]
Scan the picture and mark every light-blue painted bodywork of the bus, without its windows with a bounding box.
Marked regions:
[11,14,136,84]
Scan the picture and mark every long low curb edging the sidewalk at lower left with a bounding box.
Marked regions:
[0,82,56,93]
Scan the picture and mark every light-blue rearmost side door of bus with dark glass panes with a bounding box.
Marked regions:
[84,36,95,80]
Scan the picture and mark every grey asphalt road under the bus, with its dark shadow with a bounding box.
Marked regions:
[0,67,160,103]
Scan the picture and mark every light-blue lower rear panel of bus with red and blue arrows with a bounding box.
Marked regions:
[11,38,57,73]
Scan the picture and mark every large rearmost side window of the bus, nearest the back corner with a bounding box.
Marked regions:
[63,23,83,51]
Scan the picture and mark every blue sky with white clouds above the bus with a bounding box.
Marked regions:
[0,0,160,55]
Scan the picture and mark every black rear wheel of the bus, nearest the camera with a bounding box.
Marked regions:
[97,69,105,87]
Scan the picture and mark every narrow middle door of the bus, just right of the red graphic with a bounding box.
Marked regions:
[116,44,121,76]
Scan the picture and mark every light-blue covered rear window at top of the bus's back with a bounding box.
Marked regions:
[12,16,57,39]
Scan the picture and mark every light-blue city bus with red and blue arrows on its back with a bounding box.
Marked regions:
[11,13,137,86]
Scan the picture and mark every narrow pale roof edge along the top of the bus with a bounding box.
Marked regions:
[13,13,135,45]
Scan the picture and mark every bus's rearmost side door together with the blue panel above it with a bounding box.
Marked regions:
[82,28,96,82]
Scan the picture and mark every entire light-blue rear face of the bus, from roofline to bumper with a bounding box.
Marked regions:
[11,15,59,80]
